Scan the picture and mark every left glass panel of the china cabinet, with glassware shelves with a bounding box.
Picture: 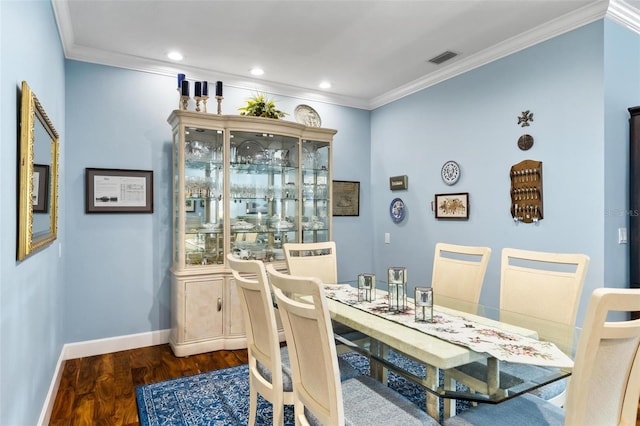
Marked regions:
[183,127,224,265]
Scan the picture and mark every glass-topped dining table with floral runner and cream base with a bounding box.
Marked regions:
[324,281,579,419]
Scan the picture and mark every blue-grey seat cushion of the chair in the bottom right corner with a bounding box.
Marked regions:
[444,394,564,426]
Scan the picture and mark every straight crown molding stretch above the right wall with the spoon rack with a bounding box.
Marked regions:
[369,1,608,109]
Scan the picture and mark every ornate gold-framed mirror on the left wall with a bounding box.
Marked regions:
[17,81,58,260]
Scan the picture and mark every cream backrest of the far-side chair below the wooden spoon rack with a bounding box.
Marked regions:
[500,248,589,325]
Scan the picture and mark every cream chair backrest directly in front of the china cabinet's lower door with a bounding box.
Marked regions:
[227,254,282,391]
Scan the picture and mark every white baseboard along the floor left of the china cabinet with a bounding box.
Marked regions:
[38,330,170,426]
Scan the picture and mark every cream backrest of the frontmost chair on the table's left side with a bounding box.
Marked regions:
[267,265,344,425]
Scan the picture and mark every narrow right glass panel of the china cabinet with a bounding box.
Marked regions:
[301,140,331,243]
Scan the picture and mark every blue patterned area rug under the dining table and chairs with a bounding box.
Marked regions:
[136,352,466,426]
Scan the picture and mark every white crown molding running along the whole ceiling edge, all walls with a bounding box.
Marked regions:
[52,0,640,110]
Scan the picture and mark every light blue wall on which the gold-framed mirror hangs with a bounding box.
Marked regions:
[0,1,67,426]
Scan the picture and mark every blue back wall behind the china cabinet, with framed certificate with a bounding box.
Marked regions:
[64,61,371,342]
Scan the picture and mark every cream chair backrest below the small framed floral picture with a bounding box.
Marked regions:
[431,243,491,303]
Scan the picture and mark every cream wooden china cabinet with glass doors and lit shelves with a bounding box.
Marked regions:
[168,110,336,356]
